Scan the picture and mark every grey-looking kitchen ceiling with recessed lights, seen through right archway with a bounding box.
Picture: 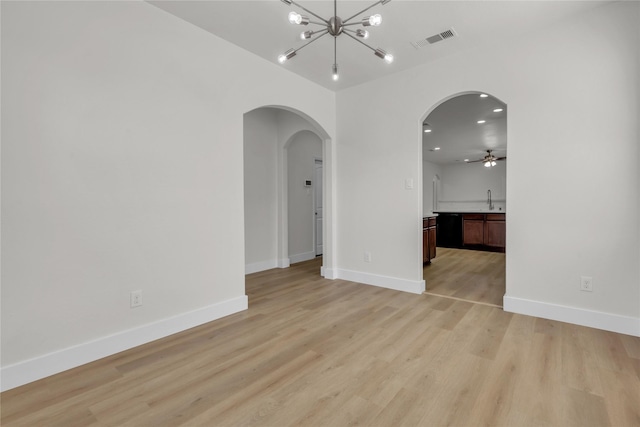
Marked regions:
[422,93,507,164]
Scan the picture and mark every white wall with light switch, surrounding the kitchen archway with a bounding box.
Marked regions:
[337,2,640,335]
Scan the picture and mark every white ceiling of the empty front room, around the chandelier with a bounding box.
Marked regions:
[149,0,606,91]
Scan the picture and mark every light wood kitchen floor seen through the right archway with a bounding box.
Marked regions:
[423,248,505,307]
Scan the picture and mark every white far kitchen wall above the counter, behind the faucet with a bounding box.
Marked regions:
[438,160,507,212]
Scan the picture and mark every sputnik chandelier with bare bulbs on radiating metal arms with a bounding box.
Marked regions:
[278,0,393,80]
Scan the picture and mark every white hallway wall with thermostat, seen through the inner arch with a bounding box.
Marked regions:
[287,131,322,263]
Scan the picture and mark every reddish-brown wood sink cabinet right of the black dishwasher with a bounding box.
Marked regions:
[462,214,506,252]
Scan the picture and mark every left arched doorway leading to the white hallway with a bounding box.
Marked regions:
[243,106,334,278]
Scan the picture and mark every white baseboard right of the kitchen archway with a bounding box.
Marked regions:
[503,295,640,337]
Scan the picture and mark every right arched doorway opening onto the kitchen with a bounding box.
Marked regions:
[421,92,507,307]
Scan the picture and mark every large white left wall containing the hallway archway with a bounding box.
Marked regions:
[1,2,335,389]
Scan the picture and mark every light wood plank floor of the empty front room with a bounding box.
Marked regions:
[1,261,640,427]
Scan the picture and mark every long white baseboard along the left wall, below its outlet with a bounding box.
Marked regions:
[0,295,248,391]
